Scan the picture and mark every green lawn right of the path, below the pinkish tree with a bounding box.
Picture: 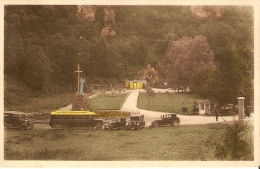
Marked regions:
[137,93,198,114]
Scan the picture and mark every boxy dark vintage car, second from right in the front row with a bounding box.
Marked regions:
[126,115,145,130]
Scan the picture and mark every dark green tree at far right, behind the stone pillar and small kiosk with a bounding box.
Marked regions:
[193,47,253,105]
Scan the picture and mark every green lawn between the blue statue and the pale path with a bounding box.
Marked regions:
[90,93,128,110]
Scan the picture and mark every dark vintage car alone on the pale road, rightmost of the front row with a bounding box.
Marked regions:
[150,113,180,127]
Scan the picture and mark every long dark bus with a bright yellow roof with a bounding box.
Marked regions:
[49,110,103,130]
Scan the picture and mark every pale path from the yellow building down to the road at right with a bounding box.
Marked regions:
[121,89,253,126]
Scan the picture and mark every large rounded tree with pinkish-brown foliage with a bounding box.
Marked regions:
[158,36,214,91]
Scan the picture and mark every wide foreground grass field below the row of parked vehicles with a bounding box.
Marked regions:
[4,124,253,161]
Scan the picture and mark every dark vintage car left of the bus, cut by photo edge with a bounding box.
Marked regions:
[4,111,34,130]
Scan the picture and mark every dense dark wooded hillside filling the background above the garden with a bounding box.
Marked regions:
[4,5,254,107]
